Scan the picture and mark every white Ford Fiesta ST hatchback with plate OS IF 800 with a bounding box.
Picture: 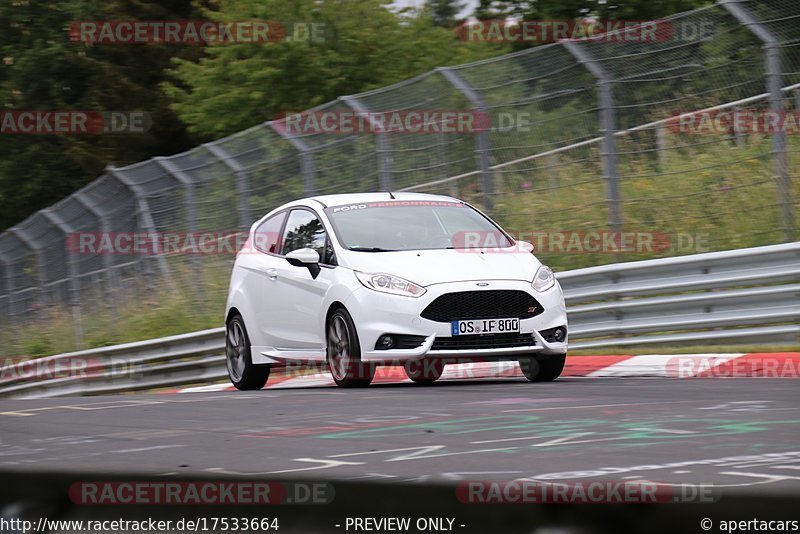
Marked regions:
[226,193,567,390]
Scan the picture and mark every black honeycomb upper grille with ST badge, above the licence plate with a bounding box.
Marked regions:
[420,289,543,323]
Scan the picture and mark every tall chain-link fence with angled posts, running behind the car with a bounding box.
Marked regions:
[0,0,800,354]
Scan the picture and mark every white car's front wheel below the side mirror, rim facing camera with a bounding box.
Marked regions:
[326,308,375,388]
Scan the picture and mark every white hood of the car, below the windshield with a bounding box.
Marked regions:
[340,249,541,286]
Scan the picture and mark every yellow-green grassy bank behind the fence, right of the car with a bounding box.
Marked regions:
[495,138,800,270]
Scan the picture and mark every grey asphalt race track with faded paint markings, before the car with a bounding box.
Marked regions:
[0,378,800,495]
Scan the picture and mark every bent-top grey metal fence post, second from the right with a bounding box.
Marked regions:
[561,41,622,232]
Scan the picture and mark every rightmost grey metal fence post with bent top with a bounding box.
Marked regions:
[718,0,796,243]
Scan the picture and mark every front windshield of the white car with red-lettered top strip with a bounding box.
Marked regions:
[326,201,513,252]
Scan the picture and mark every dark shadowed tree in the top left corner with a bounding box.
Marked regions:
[0,0,198,228]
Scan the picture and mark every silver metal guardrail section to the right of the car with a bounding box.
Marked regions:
[559,242,800,349]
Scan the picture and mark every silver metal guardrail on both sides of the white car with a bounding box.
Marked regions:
[0,242,800,397]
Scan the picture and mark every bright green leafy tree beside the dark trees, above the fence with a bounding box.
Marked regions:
[164,0,507,136]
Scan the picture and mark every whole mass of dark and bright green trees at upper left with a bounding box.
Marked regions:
[0,0,508,228]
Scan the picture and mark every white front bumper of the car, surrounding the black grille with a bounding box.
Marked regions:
[344,280,568,364]
